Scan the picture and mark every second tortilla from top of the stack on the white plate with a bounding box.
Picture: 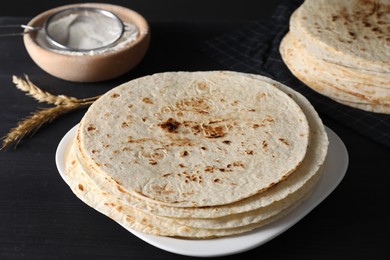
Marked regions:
[68,72,328,218]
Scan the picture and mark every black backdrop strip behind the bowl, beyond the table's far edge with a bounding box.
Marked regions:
[0,0,280,21]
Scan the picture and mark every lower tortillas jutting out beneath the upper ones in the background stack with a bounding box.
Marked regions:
[280,33,390,111]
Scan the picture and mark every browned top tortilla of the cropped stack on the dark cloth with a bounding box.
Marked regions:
[290,0,390,72]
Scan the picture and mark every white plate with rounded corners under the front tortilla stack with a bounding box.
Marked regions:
[56,126,348,257]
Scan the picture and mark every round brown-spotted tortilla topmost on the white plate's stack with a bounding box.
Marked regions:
[78,72,309,207]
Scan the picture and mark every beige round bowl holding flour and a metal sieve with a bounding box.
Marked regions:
[23,3,150,82]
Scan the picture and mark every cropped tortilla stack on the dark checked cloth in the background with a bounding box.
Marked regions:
[280,0,390,114]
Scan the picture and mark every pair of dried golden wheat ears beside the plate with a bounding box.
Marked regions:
[0,76,100,150]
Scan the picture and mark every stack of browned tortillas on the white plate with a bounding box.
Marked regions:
[66,71,328,239]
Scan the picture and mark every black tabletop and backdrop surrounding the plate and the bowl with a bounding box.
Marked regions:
[0,0,390,259]
